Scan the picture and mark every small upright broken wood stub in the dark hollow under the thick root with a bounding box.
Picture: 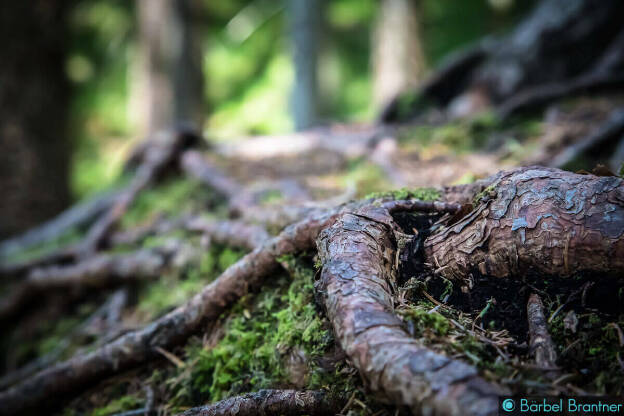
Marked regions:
[527,293,557,371]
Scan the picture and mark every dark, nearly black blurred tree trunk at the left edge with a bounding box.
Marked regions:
[0,0,70,238]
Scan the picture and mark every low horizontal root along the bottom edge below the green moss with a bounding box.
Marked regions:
[179,390,343,416]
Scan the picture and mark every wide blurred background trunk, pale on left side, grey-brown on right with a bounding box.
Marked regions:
[133,0,204,134]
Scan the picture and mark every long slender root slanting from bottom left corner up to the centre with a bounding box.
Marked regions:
[0,200,364,415]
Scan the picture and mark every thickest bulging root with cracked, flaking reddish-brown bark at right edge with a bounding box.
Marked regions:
[425,167,624,280]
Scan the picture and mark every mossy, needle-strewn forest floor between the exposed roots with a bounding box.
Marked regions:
[0,98,624,416]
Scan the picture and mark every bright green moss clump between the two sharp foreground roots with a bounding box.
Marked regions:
[168,257,356,404]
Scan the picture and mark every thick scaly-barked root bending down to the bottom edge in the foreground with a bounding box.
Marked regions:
[317,204,500,415]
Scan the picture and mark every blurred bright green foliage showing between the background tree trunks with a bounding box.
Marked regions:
[66,0,534,198]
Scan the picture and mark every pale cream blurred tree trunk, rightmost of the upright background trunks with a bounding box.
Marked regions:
[372,0,426,108]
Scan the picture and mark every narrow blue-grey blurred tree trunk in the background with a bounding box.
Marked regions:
[289,0,323,130]
